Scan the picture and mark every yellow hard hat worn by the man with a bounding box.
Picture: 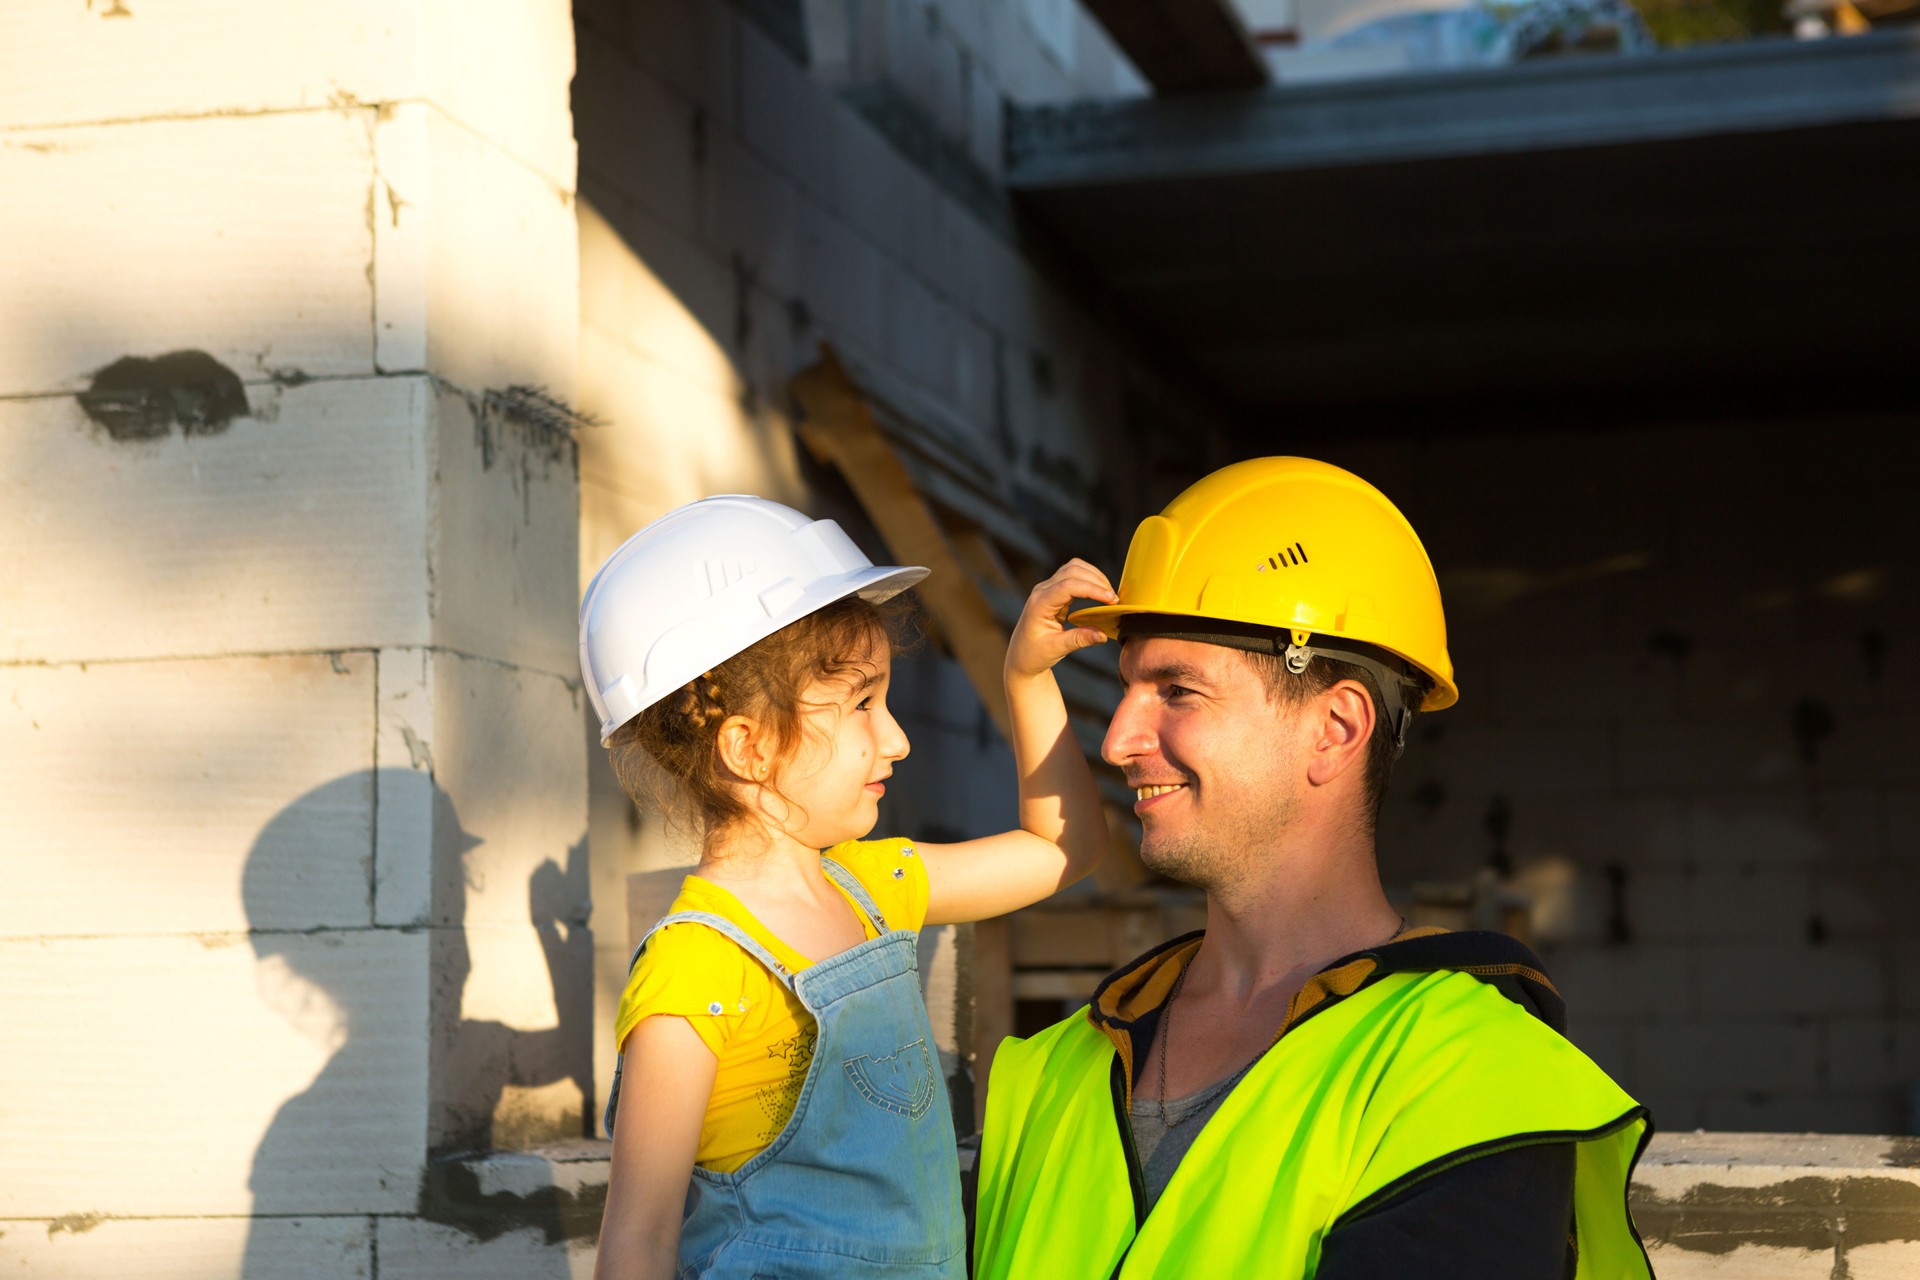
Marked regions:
[1071,459,1459,712]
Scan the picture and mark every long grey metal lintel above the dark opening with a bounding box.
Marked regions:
[1006,29,1920,194]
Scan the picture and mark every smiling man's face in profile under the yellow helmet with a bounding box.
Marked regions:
[1100,637,1300,889]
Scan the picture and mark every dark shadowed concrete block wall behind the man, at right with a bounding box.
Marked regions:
[1344,418,1920,1134]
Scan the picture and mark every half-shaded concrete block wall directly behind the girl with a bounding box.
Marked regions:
[574,0,1217,1136]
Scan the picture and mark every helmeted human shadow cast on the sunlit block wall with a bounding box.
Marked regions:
[242,770,599,1278]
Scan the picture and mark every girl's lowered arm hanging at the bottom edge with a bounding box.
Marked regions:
[593,1015,720,1280]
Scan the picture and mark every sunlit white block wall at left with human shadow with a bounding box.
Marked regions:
[0,0,591,1276]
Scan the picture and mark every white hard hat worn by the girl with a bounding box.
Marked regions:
[580,493,927,745]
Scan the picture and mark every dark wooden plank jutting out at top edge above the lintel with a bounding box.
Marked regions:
[1087,0,1269,94]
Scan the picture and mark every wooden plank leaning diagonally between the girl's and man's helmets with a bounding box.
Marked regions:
[793,347,1008,735]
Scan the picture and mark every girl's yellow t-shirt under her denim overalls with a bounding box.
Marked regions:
[614,839,927,1173]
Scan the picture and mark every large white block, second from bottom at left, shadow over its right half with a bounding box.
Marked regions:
[0,924,428,1219]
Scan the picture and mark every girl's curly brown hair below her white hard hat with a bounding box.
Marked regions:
[607,597,912,844]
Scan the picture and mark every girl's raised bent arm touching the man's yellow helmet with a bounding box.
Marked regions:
[916,560,1119,925]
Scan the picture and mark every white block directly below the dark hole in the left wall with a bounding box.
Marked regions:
[0,378,430,660]
